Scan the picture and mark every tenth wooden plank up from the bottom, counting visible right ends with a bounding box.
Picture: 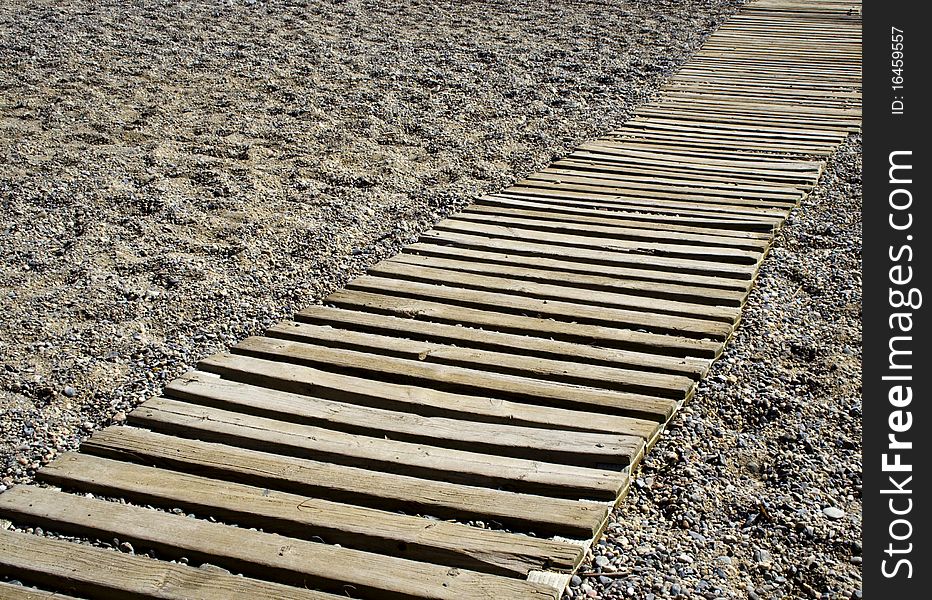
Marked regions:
[326,291,722,358]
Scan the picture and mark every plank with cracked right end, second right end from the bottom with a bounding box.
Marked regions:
[18,457,583,578]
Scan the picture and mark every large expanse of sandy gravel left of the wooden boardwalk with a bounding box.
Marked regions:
[0,0,740,491]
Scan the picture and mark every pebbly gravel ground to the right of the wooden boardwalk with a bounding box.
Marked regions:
[565,137,861,600]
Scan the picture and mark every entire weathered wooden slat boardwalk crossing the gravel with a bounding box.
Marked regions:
[0,0,861,600]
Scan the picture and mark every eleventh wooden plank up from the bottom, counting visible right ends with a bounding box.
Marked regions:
[346,276,732,341]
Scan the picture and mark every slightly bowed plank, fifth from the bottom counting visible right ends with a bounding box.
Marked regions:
[166,370,648,465]
